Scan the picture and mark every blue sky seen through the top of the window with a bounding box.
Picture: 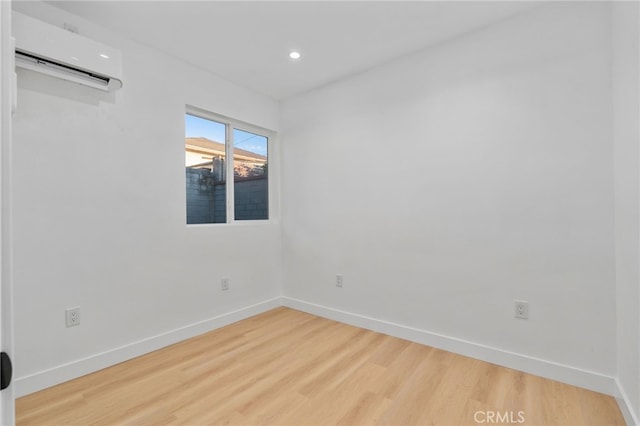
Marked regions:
[185,114,267,156]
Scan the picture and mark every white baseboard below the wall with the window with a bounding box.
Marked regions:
[15,297,282,398]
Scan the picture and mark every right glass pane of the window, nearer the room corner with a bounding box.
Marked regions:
[233,129,269,220]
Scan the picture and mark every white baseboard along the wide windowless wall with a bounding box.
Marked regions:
[282,297,617,396]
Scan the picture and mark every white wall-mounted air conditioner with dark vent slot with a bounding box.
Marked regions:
[12,12,122,92]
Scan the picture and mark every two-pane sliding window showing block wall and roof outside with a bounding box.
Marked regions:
[185,111,270,225]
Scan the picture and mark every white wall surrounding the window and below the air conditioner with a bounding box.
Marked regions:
[13,2,281,393]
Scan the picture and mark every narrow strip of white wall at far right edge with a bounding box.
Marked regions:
[612,2,640,423]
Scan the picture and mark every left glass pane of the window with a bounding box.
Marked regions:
[185,114,227,224]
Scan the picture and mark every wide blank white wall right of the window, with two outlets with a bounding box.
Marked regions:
[281,3,616,381]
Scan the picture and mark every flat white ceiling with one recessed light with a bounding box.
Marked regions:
[48,1,534,100]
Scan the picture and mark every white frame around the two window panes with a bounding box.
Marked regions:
[182,105,278,227]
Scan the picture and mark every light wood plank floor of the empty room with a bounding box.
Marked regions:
[17,308,624,426]
